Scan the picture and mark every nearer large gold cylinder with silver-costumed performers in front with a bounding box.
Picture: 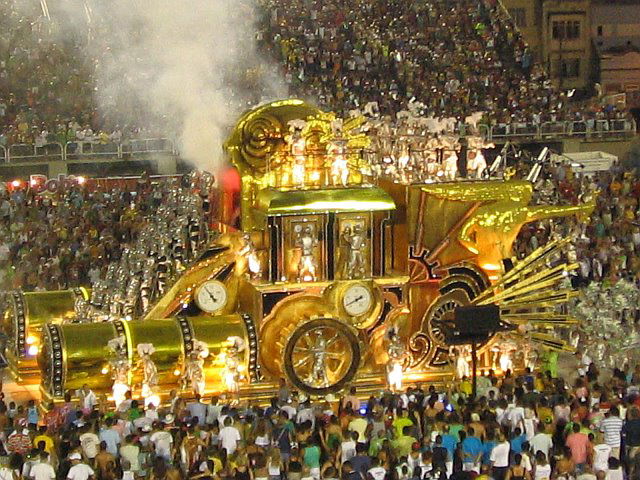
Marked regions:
[38,314,258,399]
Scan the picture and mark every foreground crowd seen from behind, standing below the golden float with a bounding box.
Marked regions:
[0,364,640,480]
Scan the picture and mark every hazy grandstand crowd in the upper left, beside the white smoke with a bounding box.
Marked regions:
[0,0,165,146]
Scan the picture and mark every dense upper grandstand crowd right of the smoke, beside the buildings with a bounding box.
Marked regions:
[259,0,632,125]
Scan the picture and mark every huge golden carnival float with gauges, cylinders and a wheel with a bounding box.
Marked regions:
[4,100,593,403]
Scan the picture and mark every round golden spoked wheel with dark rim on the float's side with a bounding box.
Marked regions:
[282,317,360,395]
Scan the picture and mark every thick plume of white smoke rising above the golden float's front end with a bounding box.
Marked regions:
[28,0,286,171]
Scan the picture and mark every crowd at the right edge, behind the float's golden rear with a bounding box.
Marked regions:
[515,163,640,286]
